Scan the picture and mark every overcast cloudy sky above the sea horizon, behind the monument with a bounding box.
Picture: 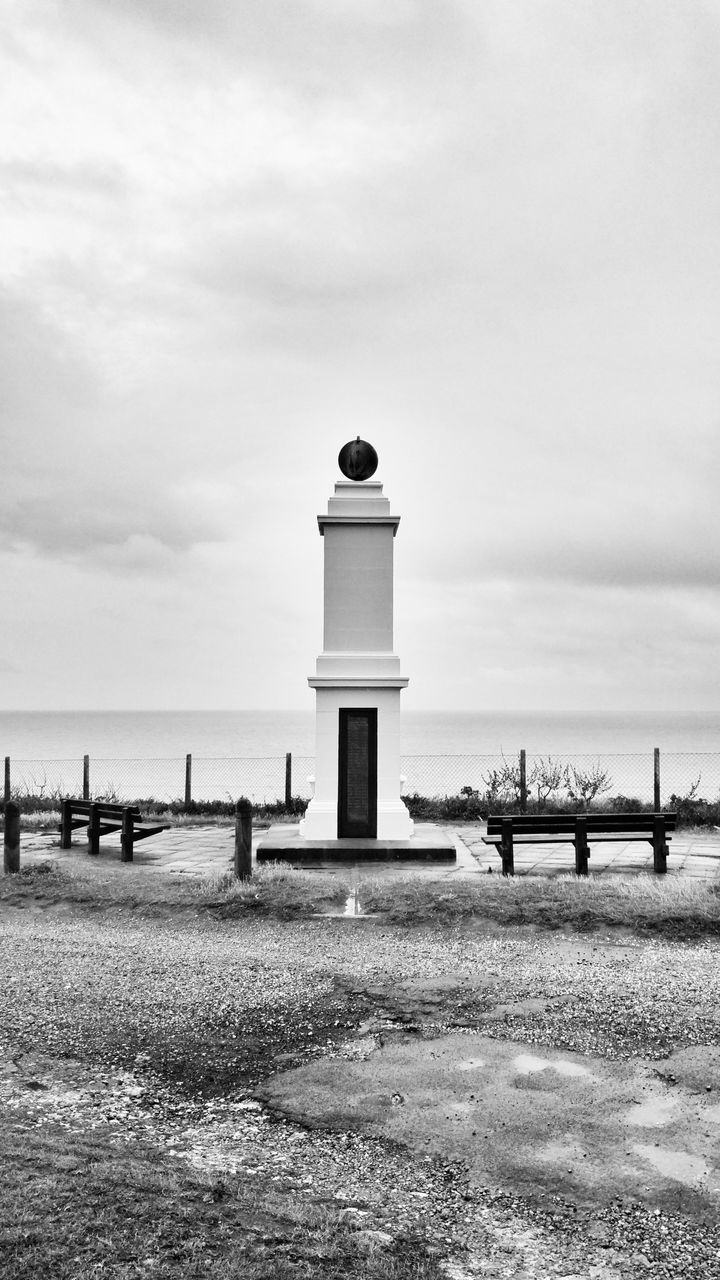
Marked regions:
[0,0,720,709]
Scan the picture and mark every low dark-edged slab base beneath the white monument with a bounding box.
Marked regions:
[258,823,457,867]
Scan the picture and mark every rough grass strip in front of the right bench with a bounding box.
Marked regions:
[360,876,720,938]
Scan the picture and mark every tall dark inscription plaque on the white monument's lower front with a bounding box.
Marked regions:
[337,707,378,840]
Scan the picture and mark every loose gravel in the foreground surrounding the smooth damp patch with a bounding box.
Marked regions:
[0,911,720,1280]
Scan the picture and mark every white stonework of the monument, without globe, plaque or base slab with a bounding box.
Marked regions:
[300,480,413,840]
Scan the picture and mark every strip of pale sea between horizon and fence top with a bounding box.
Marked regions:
[0,710,720,760]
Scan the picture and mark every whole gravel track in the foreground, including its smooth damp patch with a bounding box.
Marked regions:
[0,911,720,1280]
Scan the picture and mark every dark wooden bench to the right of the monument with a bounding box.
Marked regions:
[483,813,676,876]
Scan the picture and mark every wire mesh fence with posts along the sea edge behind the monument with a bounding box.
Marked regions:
[5,751,720,806]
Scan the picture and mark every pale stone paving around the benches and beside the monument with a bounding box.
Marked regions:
[9,823,720,879]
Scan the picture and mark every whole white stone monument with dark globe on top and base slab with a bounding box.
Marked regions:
[258,436,455,863]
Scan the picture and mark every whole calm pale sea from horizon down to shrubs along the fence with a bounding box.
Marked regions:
[0,710,720,803]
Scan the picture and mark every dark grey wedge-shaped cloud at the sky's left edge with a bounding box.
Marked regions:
[0,293,222,572]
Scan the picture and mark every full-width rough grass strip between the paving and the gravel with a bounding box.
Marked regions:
[0,858,720,938]
